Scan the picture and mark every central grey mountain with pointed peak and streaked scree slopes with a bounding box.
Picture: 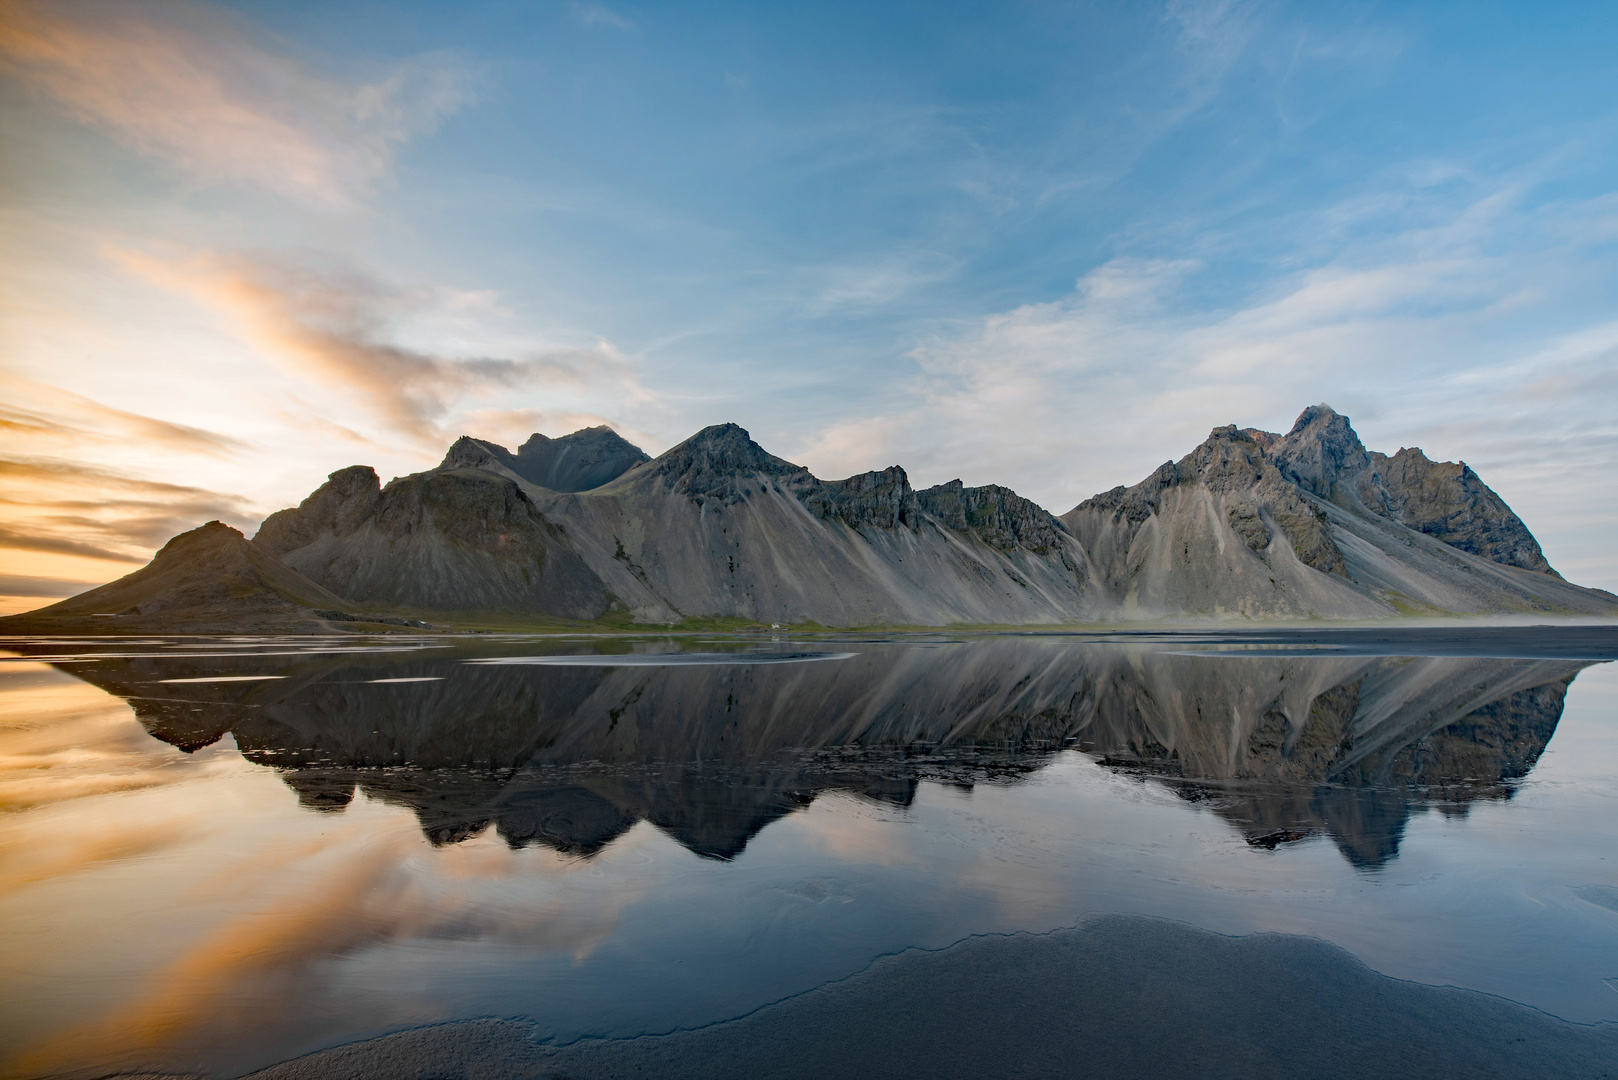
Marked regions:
[547,424,1100,627]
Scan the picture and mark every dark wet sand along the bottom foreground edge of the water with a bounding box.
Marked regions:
[231,916,1618,1080]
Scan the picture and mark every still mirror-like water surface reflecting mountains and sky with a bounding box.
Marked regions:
[0,636,1618,1075]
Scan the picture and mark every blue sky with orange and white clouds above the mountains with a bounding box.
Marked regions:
[0,0,1618,610]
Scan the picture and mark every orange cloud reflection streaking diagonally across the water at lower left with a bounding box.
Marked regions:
[8,824,642,1075]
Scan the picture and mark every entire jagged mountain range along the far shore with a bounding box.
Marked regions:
[0,405,1618,633]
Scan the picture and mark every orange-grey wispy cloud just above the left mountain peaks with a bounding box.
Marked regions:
[115,251,644,445]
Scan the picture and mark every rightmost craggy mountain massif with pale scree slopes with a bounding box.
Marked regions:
[1061,405,1618,619]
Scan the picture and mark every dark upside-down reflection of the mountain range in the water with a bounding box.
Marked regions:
[50,638,1587,868]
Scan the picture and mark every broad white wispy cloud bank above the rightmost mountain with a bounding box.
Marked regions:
[798,177,1618,586]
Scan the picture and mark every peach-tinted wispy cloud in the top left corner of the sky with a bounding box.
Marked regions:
[0,0,469,207]
